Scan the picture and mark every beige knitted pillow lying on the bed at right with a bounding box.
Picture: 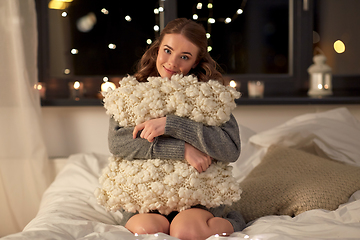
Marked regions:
[232,145,360,222]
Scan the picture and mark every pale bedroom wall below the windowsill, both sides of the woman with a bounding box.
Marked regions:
[42,104,360,158]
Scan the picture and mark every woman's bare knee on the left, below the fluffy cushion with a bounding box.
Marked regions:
[125,213,170,234]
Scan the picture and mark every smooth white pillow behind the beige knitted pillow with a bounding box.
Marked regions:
[249,108,360,166]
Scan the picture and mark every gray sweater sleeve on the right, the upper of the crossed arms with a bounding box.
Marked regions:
[165,114,241,162]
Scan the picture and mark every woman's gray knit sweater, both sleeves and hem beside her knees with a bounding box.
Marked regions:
[108,115,245,231]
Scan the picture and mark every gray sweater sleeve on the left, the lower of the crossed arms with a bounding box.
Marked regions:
[108,118,185,160]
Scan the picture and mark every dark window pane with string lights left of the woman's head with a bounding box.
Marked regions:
[36,0,160,99]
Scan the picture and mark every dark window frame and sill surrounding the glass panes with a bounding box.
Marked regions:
[35,0,360,106]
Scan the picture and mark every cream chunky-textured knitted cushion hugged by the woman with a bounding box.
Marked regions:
[95,75,241,214]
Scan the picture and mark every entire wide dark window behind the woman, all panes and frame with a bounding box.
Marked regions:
[36,0,360,105]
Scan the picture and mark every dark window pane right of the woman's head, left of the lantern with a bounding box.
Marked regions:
[177,0,303,94]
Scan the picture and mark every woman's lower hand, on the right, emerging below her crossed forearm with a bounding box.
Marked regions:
[185,143,212,173]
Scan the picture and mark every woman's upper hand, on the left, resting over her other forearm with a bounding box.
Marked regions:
[133,117,166,142]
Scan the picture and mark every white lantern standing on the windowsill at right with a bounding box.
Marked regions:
[308,54,333,97]
